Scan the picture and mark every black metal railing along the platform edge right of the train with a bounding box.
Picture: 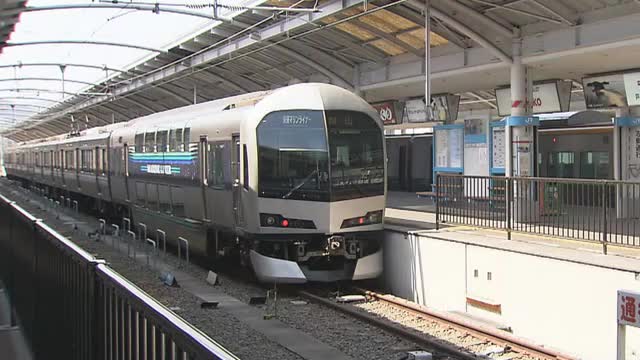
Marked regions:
[435,174,640,252]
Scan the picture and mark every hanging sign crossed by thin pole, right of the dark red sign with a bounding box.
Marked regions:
[402,94,460,124]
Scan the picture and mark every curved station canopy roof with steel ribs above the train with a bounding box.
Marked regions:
[0,0,640,141]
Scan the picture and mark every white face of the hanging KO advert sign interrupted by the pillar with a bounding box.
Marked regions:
[496,81,570,116]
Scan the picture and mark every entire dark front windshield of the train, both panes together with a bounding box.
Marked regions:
[257,110,384,201]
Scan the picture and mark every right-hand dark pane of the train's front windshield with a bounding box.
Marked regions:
[326,111,384,201]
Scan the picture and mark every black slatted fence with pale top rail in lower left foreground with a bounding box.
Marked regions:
[0,196,237,360]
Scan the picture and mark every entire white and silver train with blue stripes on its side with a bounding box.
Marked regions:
[4,84,386,283]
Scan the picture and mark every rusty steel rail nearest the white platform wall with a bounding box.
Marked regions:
[354,288,575,360]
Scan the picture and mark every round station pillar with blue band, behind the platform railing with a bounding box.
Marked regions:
[505,37,539,222]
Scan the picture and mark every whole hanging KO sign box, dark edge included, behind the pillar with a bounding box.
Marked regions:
[496,80,571,116]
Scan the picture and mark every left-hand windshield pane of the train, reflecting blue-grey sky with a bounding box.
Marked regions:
[257,110,329,201]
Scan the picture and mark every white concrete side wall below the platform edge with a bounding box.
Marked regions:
[384,232,640,360]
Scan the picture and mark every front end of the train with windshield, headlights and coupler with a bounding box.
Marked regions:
[250,85,386,283]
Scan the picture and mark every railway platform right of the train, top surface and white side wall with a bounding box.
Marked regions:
[384,199,640,359]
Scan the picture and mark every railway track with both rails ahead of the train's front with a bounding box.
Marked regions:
[299,288,574,360]
